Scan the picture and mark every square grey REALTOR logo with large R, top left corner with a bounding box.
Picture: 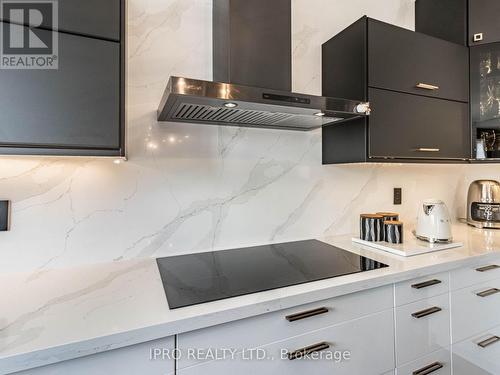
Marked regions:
[0,0,58,69]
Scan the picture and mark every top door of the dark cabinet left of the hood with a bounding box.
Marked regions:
[2,0,123,41]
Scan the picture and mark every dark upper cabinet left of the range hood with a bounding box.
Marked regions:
[0,0,125,156]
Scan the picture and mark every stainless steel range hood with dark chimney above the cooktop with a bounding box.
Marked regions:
[158,0,370,130]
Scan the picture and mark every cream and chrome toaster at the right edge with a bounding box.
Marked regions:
[467,180,500,228]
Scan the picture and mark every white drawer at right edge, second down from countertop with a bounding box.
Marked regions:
[451,279,500,342]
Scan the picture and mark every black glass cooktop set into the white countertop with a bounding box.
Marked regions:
[156,240,387,309]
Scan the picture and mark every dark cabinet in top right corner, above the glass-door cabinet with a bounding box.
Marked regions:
[415,0,500,46]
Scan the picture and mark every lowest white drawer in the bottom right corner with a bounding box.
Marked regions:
[453,326,500,375]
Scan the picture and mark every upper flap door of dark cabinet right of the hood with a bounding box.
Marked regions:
[368,20,469,102]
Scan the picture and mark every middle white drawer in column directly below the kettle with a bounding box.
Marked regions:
[396,294,450,366]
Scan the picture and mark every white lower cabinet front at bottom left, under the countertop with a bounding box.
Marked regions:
[16,337,175,375]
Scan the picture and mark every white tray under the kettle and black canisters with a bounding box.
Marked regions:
[352,232,464,257]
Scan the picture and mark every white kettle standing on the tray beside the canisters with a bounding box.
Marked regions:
[415,199,452,243]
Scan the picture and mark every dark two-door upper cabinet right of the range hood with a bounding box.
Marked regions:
[322,17,471,164]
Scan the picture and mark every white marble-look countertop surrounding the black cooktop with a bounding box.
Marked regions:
[0,224,500,374]
